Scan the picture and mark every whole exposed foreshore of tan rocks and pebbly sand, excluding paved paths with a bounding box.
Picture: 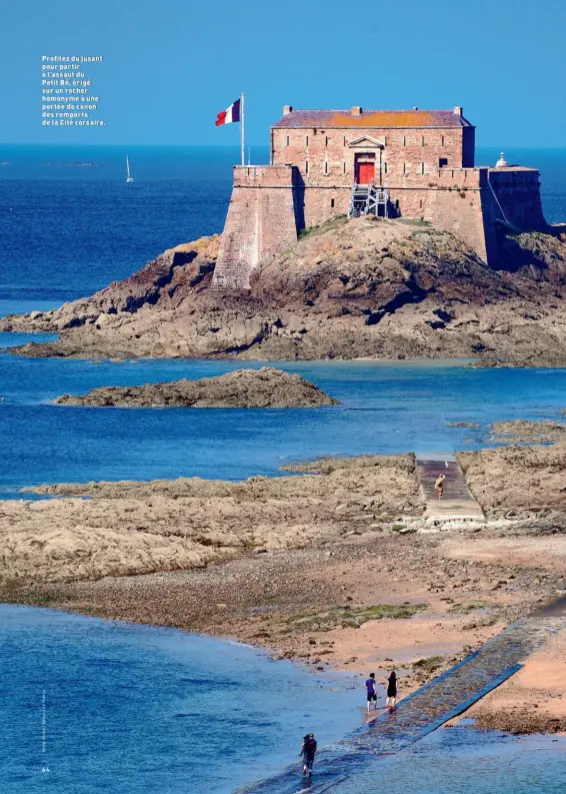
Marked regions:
[0,436,566,732]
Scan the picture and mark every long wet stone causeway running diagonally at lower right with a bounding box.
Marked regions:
[237,597,566,794]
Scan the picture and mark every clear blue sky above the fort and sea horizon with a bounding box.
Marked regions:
[0,0,566,148]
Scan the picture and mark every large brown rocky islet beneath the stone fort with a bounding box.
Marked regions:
[0,218,566,366]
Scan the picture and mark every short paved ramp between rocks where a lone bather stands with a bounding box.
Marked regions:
[417,459,484,521]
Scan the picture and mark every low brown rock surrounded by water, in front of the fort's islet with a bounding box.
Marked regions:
[56,367,338,408]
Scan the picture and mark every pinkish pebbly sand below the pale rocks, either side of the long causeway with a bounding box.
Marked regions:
[5,533,566,732]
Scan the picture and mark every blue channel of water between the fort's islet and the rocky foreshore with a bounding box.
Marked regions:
[0,346,566,497]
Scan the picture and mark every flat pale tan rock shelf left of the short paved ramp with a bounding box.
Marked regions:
[0,456,422,585]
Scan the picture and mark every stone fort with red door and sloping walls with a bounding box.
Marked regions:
[213,105,546,289]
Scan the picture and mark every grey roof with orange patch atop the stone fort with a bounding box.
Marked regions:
[273,107,473,129]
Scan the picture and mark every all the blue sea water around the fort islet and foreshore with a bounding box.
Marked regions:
[0,144,566,794]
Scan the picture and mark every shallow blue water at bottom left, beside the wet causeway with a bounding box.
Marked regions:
[0,605,363,794]
